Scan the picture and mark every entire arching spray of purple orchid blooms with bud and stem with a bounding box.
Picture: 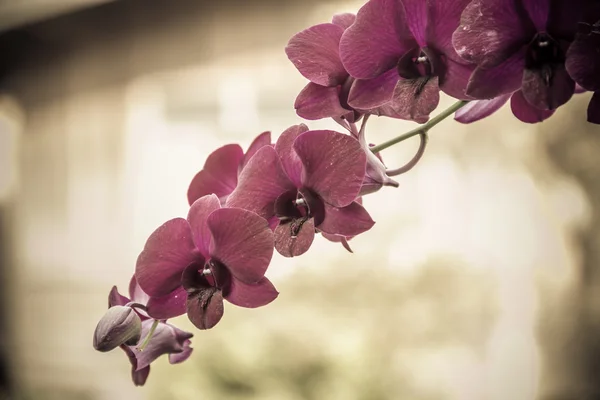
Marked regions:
[94,0,600,385]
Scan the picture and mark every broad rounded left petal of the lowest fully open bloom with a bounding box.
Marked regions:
[135,218,198,297]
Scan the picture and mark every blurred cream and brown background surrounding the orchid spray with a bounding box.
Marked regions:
[0,0,600,400]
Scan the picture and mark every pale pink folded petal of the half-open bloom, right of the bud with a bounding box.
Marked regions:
[127,320,194,371]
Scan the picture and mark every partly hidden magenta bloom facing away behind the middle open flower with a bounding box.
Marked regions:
[187,132,271,205]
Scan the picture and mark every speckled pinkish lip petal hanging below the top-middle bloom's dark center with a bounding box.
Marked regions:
[390,76,440,123]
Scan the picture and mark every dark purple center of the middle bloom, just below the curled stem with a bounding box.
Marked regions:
[275,188,325,237]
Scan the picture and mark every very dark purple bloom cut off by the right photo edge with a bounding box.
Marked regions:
[566,1,600,124]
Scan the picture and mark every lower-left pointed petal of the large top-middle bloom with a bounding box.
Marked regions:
[348,69,400,110]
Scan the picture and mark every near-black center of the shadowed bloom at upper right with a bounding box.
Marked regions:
[525,32,565,85]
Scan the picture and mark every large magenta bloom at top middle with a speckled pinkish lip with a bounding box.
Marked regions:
[340,0,473,122]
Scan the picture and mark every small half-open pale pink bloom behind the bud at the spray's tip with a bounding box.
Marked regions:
[97,277,194,386]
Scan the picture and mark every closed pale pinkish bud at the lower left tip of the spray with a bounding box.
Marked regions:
[94,306,142,352]
